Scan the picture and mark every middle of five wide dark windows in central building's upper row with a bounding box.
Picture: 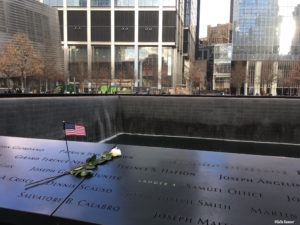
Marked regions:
[115,11,134,42]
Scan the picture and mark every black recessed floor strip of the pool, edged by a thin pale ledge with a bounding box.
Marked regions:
[103,133,300,158]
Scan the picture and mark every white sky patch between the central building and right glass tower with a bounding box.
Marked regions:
[200,0,230,37]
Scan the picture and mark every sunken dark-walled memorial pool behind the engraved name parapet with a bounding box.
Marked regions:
[0,95,300,157]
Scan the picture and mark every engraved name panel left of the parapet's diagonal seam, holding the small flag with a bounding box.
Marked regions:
[0,137,108,224]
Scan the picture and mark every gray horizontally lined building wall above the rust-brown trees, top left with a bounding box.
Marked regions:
[0,0,63,69]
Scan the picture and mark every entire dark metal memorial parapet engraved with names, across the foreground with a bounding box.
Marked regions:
[0,137,300,225]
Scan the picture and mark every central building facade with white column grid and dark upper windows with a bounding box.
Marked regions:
[43,0,199,91]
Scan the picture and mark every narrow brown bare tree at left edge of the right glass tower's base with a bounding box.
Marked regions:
[231,61,246,95]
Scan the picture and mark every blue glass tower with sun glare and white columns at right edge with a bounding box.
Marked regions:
[232,0,300,95]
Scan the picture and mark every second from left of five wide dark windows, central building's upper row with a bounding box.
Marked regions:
[91,11,111,42]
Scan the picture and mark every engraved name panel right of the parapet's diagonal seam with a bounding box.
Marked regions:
[54,146,300,225]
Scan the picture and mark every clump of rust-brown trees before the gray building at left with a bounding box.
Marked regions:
[0,33,63,92]
